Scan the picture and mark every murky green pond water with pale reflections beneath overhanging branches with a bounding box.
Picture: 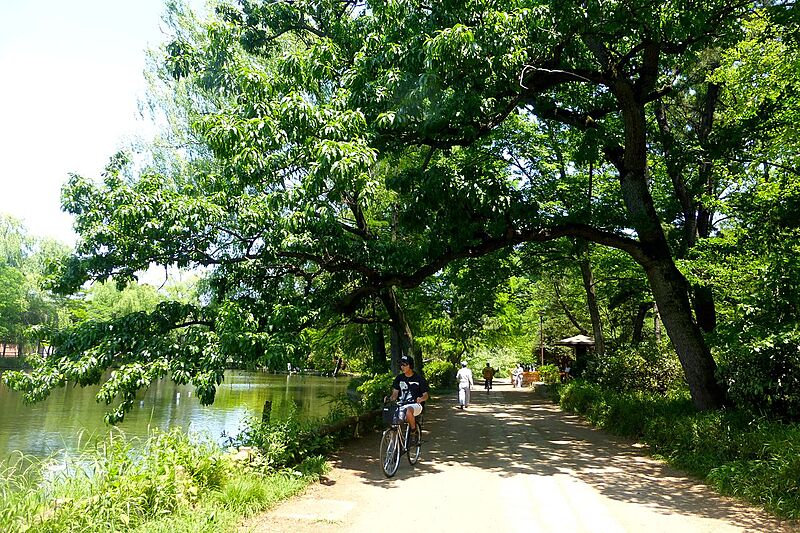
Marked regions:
[0,371,348,462]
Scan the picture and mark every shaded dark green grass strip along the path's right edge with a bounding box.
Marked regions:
[557,381,800,519]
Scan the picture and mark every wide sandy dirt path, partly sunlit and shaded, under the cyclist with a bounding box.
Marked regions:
[241,383,800,533]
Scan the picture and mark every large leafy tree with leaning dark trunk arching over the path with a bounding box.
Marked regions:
[11,0,795,415]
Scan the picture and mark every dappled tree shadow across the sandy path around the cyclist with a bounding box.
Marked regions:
[334,385,800,531]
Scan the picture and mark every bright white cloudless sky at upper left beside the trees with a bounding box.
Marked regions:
[0,0,194,245]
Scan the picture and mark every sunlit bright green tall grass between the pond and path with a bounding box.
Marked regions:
[0,430,327,533]
